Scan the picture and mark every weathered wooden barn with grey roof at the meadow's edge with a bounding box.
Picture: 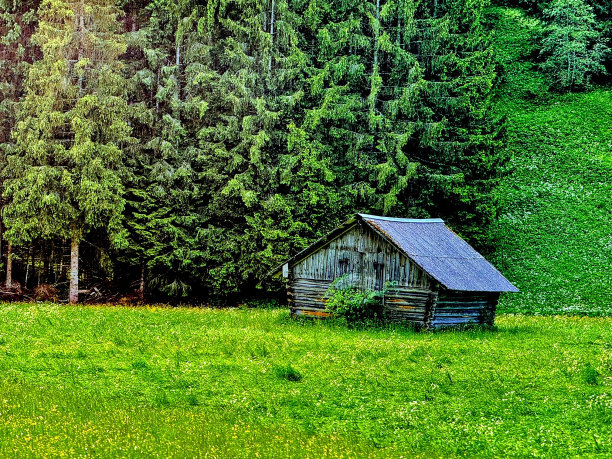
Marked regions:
[273,214,518,328]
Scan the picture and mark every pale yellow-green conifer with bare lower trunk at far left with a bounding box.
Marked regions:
[3,0,130,302]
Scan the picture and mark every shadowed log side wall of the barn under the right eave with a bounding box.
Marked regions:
[431,289,499,328]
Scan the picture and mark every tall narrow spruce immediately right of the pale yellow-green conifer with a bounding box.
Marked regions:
[120,1,206,297]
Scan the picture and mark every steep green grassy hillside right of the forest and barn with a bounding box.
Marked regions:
[492,8,612,315]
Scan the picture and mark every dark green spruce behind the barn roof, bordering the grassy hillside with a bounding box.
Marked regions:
[404,0,506,249]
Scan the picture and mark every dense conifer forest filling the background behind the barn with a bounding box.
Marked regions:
[0,0,612,302]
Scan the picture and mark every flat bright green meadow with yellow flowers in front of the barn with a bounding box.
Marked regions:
[0,304,612,457]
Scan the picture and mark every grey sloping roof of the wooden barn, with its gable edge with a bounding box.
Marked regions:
[274,214,518,292]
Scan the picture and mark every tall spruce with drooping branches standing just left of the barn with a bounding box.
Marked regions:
[177,0,304,293]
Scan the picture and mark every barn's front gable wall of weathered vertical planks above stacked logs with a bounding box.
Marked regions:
[288,225,435,324]
